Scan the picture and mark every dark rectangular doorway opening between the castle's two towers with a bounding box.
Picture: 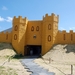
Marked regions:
[25,45,41,56]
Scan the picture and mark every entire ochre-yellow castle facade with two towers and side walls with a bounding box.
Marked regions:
[0,13,75,55]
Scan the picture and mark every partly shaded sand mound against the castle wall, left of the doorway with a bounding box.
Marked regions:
[0,43,16,57]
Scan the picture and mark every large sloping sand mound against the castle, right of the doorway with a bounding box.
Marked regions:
[43,44,75,63]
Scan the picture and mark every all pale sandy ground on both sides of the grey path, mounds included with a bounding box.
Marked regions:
[0,43,75,75]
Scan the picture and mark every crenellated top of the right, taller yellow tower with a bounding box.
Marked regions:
[43,13,59,22]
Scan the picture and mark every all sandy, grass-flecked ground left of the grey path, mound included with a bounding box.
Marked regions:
[0,43,31,75]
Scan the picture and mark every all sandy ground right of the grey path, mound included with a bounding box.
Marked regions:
[35,44,75,75]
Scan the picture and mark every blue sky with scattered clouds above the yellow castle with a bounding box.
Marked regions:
[0,0,75,31]
